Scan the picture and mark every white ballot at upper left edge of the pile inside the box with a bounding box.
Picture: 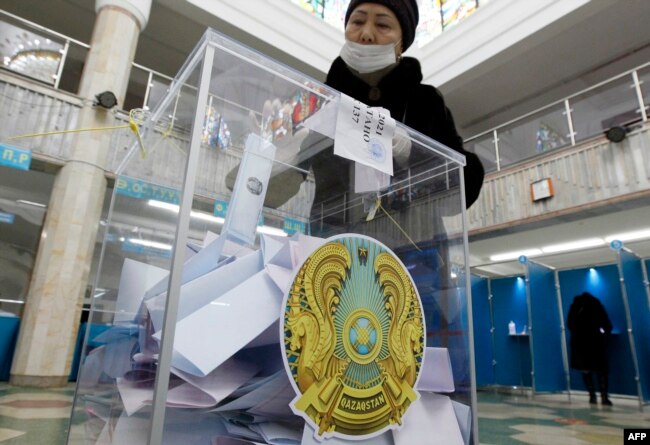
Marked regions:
[113,258,169,324]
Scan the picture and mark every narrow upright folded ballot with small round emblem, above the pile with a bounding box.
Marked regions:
[221,133,276,245]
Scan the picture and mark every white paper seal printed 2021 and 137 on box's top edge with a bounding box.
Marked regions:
[334,94,395,176]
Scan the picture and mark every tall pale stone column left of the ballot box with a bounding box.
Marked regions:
[10,0,151,387]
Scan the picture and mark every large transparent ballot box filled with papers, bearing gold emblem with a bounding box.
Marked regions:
[68,31,478,445]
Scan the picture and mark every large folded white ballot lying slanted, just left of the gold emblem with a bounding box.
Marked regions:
[159,271,282,376]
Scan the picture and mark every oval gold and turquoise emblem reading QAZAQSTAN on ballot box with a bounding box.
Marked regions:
[283,235,424,440]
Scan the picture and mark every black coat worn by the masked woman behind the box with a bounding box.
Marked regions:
[310,57,484,207]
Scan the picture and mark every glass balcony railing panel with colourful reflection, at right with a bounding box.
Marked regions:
[498,105,571,168]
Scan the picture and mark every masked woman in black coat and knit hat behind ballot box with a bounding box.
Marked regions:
[304,0,484,220]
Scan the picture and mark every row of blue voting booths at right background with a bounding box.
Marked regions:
[472,253,650,404]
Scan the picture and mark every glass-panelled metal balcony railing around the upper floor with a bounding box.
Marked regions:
[0,10,650,172]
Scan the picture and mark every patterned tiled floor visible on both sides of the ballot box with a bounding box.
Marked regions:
[0,383,650,445]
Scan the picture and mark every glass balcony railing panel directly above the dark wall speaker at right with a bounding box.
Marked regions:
[570,75,641,142]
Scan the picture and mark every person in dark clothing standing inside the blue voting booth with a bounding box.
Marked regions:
[567,292,612,406]
